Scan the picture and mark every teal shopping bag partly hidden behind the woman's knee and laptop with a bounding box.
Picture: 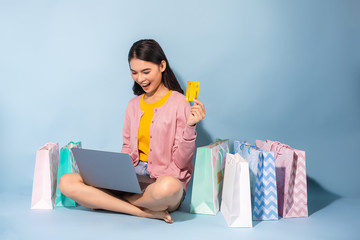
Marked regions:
[55,142,81,207]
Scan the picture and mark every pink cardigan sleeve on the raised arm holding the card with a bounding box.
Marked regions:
[172,100,196,170]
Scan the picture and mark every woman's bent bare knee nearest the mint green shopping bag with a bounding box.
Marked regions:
[125,176,183,212]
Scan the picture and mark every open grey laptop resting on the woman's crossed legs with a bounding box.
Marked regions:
[71,148,145,193]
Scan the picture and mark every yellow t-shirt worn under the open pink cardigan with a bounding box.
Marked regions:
[138,91,172,162]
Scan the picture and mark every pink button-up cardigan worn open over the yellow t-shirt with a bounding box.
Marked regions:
[121,91,196,191]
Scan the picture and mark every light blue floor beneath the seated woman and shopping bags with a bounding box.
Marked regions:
[0,180,360,240]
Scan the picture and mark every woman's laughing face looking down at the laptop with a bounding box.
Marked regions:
[130,58,166,96]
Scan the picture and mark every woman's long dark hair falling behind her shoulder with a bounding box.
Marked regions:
[128,39,184,96]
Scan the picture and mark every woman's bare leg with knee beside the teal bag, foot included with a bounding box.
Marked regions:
[59,173,173,222]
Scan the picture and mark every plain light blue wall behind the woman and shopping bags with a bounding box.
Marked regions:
[0,0,360,197]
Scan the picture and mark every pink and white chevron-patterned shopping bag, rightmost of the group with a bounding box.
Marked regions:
[255,140,308,218]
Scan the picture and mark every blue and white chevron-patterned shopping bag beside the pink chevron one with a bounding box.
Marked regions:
[234,141,279,220]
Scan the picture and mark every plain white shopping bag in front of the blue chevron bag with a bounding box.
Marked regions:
[220,153,252,227]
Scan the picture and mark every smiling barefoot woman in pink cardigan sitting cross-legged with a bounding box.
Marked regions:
[59,40,205,223]
